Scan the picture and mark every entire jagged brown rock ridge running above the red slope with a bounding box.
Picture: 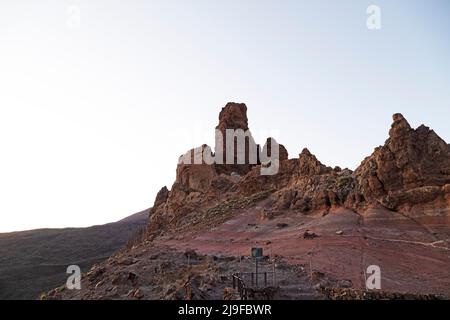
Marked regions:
[151,103,450,235]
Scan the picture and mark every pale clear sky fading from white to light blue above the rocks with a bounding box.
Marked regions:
[0,0,450,232]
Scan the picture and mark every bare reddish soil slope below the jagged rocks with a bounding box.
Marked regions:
[155,202,450,296]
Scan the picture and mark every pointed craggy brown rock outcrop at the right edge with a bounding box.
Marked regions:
[352,114,450,212]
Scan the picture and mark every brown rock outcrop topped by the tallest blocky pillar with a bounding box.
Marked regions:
[150,103,268,231]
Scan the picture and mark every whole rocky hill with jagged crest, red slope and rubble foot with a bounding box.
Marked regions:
[46,103,450,299]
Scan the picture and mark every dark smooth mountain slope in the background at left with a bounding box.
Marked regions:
[0,210,149,299]
